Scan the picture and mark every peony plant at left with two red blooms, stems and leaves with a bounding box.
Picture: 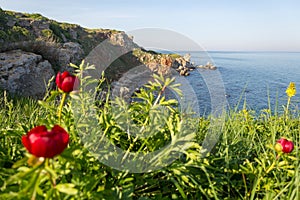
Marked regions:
[0,67,78,199]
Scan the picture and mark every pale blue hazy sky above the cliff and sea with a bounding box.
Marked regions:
[0,0,300,51]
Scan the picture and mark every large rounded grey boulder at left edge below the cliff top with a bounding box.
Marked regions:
[0,50,55,98]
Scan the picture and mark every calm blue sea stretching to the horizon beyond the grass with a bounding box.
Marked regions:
[180,52,300,113]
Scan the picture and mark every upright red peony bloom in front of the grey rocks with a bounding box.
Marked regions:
[55,71,79,92]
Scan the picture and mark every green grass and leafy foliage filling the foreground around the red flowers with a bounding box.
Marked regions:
[0,63,300,199]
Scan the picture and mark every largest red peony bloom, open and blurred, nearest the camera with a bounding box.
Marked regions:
[22,125,69,158]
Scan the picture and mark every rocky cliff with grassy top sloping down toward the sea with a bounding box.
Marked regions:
[0,9,195,98]
